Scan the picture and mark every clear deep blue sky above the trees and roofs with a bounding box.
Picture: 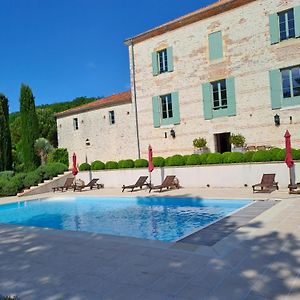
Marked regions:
[0,0,217,112]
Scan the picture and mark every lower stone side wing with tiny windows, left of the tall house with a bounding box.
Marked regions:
[57,93,137,163]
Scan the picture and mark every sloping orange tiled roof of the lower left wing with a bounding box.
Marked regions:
[55,91,131,118]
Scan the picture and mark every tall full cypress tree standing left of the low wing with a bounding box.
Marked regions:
[20,84,39,170]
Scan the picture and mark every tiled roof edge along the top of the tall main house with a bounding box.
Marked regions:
[125,0,256,46]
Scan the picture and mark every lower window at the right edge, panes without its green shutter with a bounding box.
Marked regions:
[281,66,300,99]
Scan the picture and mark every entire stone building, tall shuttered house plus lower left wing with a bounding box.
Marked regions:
[57,0,300,161]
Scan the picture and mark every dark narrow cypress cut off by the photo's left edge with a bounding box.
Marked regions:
[0,94,12,171]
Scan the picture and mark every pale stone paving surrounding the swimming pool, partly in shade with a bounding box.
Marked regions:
[0,188,300,300]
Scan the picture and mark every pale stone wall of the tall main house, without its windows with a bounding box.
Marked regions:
[126,0,300,157]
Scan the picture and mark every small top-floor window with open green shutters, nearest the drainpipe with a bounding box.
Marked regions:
[152,47,173,76]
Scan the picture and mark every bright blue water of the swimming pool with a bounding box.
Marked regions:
[0,197,250,241]
